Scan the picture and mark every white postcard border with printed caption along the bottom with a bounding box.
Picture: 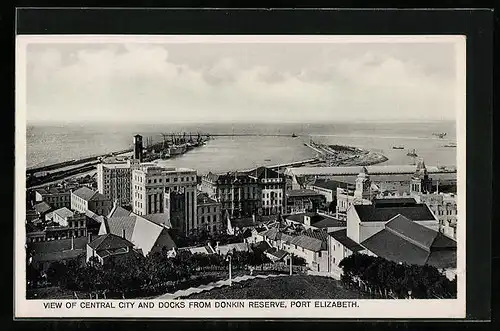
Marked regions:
[14,35,466,319]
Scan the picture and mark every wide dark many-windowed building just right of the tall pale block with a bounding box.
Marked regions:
[201,172,262,218]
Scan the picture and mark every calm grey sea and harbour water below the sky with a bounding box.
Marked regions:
[26,121,457,174]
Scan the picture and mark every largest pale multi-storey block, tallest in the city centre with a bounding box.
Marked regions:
[132,164,197,233]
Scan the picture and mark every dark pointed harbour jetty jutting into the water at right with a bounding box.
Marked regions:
[304,141,388,167]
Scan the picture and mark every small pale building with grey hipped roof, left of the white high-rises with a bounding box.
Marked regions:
[71,186,113,216]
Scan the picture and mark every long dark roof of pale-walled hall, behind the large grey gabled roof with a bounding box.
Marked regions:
[354,204,434,222]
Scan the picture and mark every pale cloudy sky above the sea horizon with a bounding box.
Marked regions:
[26,43,456,123]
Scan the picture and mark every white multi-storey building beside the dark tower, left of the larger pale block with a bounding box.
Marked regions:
[97,159,139,206]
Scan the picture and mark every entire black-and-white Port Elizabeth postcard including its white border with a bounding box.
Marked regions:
[15,35,466,318]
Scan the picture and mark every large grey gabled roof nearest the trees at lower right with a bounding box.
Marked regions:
[361,214,457,269]
